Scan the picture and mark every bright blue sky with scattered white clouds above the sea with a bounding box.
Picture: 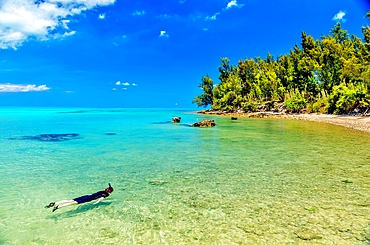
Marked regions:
[0,0,370,108]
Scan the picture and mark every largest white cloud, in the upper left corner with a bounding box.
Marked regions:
[0,0,115,49]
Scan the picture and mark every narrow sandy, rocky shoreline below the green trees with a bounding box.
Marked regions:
[197,110,370,134]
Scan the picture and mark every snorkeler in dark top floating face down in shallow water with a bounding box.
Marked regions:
[45,183,113,212]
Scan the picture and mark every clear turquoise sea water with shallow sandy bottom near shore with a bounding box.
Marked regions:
[0,108,370,244]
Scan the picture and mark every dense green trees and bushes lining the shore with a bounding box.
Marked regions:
[193,11,370,114]
